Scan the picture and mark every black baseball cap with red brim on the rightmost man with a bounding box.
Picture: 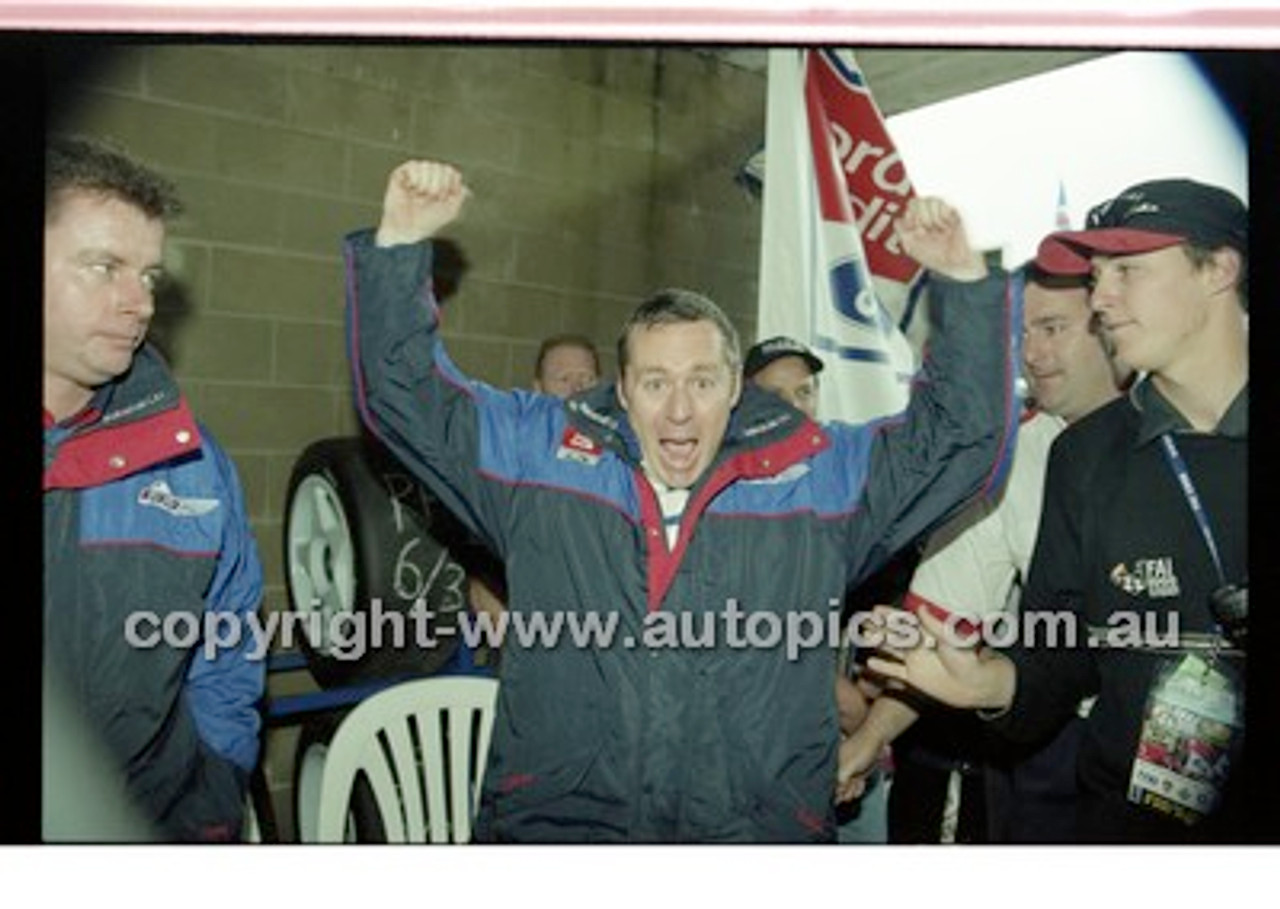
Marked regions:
[1036,179,1249,274]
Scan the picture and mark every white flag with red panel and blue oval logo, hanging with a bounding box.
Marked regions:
[758,50,925,422]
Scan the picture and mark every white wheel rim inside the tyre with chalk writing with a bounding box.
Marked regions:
[285,474,356,656]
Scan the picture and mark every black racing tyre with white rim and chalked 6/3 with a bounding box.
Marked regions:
[284,438,466,688]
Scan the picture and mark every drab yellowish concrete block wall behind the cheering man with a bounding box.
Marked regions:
[49,41,764,839]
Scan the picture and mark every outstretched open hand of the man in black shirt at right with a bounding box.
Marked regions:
[867,606,1018,708]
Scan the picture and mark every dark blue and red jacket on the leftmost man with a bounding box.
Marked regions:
[44,347,265,840]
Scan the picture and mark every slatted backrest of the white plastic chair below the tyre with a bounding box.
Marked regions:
[316,676,498,842]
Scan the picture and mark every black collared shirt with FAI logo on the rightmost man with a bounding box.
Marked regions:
[993,382,1248,842]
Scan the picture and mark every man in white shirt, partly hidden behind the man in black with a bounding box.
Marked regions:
[837,252,1130,842]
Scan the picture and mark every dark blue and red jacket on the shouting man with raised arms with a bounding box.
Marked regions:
[346,232,1018,842]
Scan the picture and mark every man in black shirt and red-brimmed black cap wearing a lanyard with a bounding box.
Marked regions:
[872,179,1251,842]
